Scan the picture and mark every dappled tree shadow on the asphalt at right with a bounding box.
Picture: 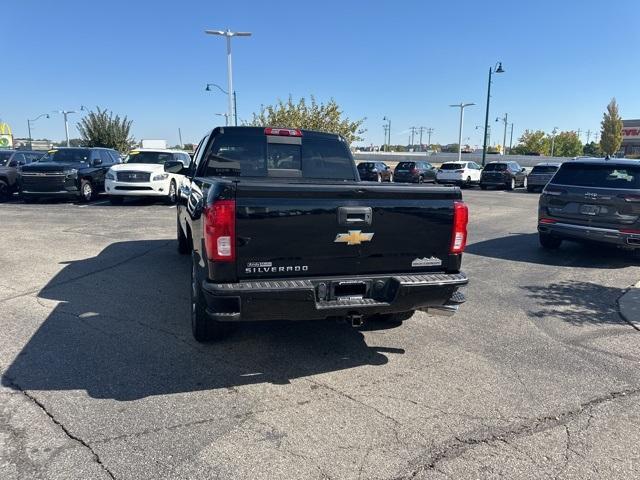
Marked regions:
[521,280,626,326]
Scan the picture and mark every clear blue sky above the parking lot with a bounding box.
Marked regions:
[5,0,640,144]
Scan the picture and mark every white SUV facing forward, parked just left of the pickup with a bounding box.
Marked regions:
[104,148,191,205]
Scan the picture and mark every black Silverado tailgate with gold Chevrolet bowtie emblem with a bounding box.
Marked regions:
[236,184,461,279]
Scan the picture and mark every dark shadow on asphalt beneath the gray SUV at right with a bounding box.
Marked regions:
[465,233,637,269]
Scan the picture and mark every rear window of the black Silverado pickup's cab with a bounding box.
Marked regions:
[204,133,355,180]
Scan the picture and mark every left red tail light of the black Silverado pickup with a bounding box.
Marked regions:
[203,200,236,262]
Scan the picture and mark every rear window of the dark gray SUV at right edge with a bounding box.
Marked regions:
[551,163,640,189]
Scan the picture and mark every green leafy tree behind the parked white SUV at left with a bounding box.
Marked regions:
[78,107,135,153]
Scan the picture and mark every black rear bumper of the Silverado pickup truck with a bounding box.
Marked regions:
[202,273,468,322]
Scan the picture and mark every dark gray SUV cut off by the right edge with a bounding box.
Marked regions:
[538,159,640,254]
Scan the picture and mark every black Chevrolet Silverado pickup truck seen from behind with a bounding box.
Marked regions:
[172,127,468,341]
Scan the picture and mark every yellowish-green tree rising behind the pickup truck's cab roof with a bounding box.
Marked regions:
[249,95,365,143]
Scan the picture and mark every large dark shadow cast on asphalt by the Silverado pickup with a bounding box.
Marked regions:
[2,240,404,401]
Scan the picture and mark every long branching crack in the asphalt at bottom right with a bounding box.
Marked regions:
[395,387,640,479]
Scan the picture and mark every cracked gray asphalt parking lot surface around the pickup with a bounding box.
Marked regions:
[0,187,640,479]
